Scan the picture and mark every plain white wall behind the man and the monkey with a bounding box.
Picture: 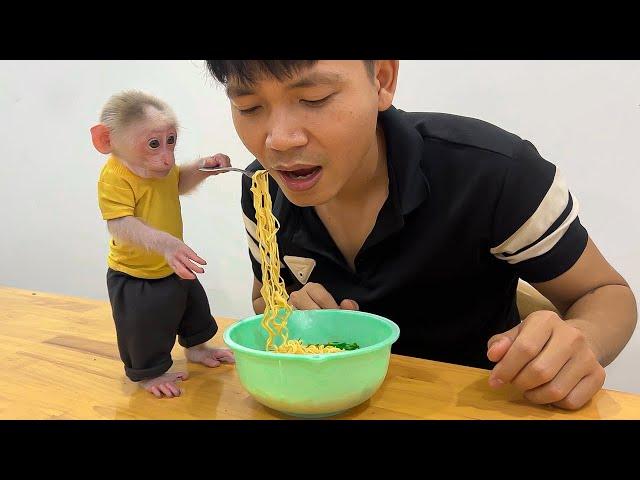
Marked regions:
[0,61,640,393]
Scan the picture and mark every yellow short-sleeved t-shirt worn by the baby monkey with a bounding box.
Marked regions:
[98,155,182,278]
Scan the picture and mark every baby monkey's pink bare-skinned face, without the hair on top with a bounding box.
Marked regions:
[114,116,178,178]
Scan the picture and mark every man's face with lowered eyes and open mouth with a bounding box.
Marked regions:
[227,60,378,206]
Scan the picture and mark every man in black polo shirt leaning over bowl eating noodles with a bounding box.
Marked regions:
[207,60,637,409]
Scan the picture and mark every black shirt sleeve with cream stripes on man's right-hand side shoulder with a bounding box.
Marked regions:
[491,140,588,282]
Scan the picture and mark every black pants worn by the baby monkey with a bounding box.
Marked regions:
[107,268,218,382]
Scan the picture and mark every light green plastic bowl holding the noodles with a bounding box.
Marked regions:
[224,310,400,418]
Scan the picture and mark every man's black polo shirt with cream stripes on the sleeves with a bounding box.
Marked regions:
[242,107,587,368]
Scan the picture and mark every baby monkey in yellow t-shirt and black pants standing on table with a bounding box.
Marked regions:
[91,91,234,397]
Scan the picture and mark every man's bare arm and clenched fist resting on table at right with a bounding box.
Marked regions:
[487,239,637,410]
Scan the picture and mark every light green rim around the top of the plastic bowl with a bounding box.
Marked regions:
[223,308,400,362]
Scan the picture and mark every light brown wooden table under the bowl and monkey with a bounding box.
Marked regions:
[0,287,640,419]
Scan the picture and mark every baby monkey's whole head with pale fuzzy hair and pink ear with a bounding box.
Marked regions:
[91,92,178,178]
